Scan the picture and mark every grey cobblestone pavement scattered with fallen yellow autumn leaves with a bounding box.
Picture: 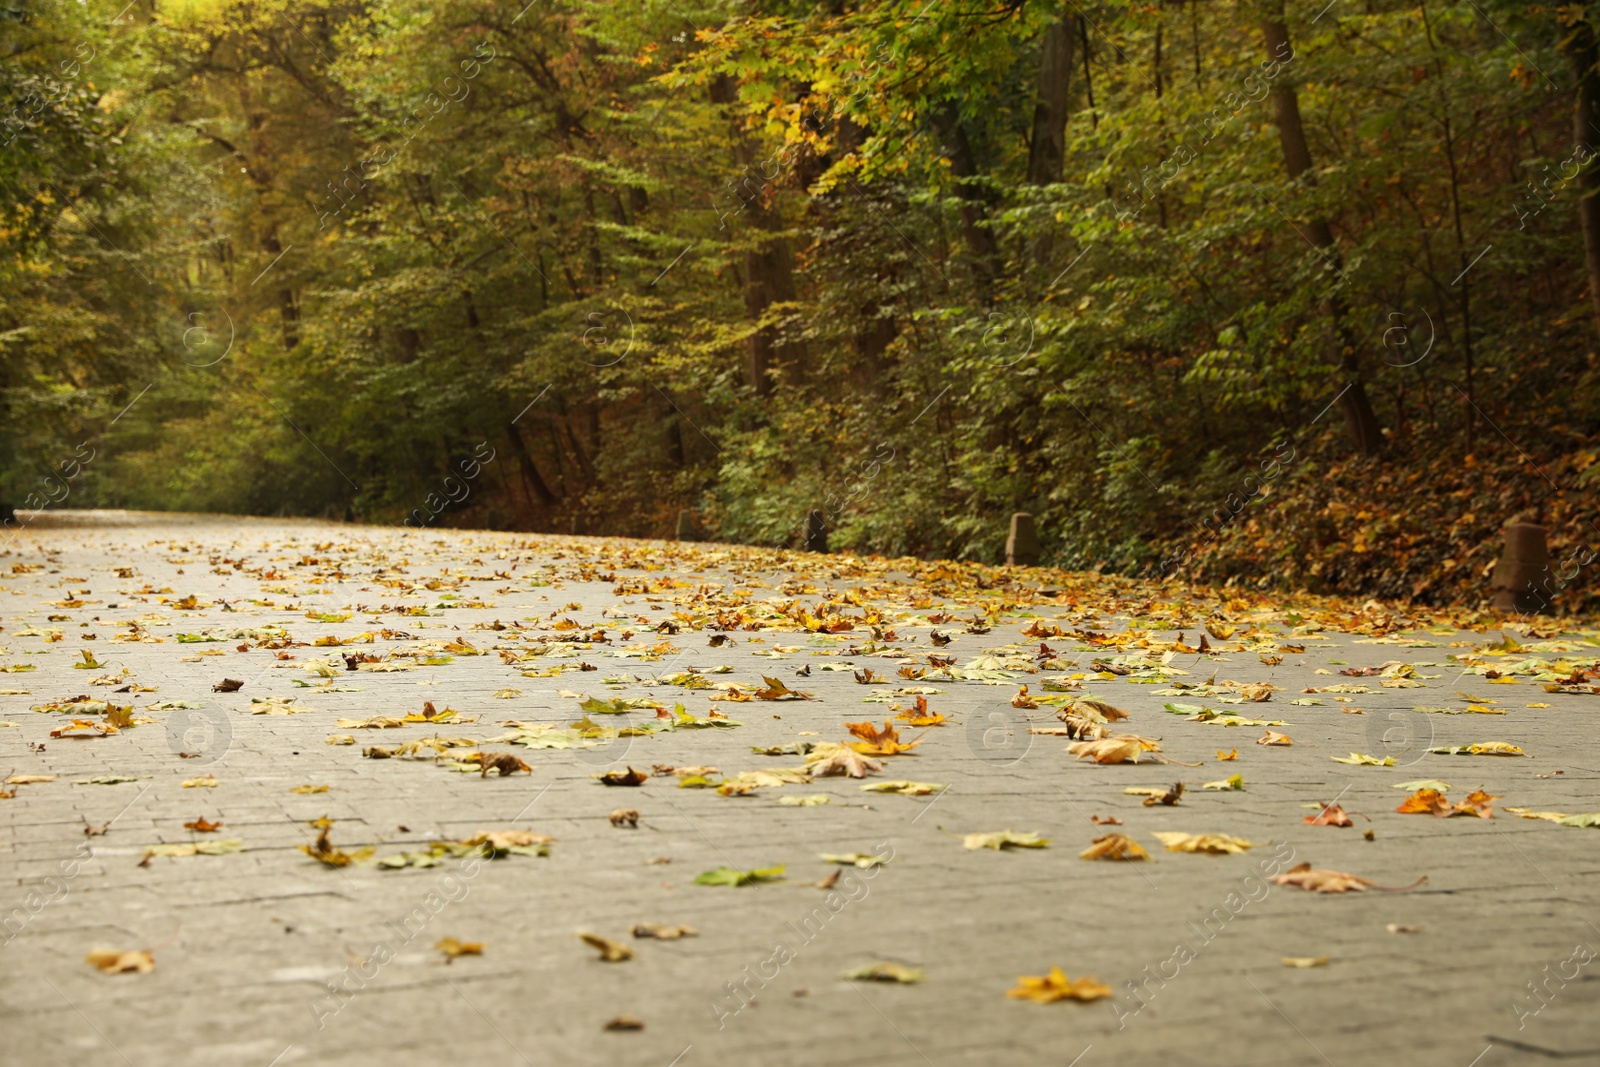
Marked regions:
[0,514,1600,1067]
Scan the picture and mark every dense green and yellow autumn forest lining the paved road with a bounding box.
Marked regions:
[0,0,1600,609]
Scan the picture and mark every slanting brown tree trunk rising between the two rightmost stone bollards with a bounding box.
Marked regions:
[1261,0,1384,456]
